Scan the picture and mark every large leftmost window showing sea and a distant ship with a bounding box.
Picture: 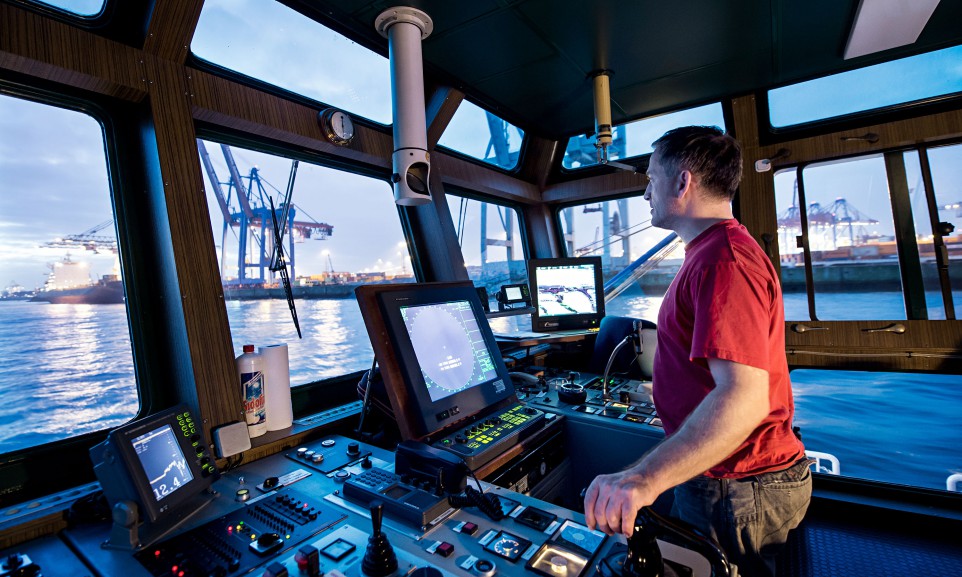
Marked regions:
[0,96,140,453]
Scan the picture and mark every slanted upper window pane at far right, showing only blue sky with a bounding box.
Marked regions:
[768,46,962,128]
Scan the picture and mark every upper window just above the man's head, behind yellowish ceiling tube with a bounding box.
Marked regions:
[561,102,725,169]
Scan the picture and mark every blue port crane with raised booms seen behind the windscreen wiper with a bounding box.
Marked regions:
[197,139,334,285]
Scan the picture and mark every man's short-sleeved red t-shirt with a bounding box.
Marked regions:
[652,220,805,479]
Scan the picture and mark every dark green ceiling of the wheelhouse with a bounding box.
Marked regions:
[281,0,962,137]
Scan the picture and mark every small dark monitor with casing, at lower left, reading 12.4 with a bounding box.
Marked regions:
[90,405,218,522]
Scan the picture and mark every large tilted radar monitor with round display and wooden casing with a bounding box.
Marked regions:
[356,283,515,441]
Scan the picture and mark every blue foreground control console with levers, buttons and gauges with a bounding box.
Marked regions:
[33,432,709,577]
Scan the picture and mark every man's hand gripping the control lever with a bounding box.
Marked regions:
[585,469,658,537]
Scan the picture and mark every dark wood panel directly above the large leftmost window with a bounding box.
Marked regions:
[0,4,147,101]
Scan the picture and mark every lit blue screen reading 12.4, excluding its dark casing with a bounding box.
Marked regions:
[131,424,194,501]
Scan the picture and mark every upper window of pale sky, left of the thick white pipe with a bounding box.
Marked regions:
[190,0,391,124]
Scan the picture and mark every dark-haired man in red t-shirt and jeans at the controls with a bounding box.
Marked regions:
[585,126,811,575]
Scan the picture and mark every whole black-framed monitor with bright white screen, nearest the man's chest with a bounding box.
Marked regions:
[528,257,605,331]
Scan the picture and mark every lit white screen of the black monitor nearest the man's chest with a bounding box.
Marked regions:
[535,264,598,317]
